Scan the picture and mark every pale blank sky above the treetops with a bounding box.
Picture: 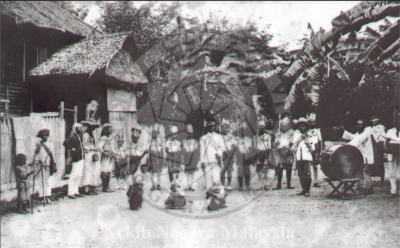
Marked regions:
[74,1,360,50]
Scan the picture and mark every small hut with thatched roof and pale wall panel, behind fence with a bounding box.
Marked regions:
[29,33,148,131]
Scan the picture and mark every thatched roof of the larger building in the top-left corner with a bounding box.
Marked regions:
[0,1,93,37]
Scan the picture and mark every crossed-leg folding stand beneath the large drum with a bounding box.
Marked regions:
[325,178,365,200]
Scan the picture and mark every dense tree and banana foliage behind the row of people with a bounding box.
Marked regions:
[98,1,396,130]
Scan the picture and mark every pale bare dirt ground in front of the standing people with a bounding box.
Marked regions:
[1,169,400,248]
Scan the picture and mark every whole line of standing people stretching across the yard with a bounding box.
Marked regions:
[15,110,400,213]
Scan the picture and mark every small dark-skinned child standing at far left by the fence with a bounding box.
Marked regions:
[15,153,35,214]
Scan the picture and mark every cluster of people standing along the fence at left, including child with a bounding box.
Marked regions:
[15,121,120,213]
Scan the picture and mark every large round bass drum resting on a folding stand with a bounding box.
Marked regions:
[321,144,364,180]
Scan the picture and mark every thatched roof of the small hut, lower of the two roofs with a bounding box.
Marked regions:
[30,34,148,85]
